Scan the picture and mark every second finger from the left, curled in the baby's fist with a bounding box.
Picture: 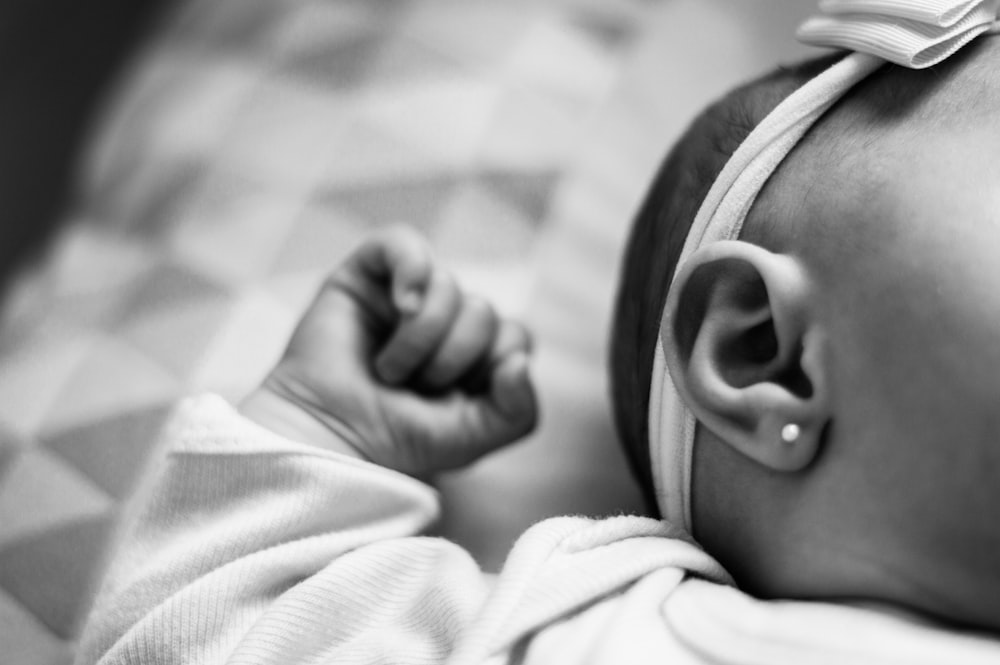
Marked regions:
[375,268,461,384]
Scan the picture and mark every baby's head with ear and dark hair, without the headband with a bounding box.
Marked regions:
[612,38,1000,630]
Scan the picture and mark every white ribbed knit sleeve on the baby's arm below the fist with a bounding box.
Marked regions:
[76,396,487,665]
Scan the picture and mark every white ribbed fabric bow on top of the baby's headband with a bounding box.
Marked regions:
[797,0,1000,69]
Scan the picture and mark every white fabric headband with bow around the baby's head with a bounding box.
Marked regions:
[649,0,1000,533]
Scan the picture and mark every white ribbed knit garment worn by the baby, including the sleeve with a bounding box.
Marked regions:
[77,397,1000,665]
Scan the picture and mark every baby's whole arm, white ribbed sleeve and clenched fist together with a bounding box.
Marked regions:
[78,232,535,663]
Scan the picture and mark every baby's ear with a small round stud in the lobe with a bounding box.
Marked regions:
[664,241,830,471]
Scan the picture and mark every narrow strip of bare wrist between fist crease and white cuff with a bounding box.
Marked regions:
[238,383,367,459]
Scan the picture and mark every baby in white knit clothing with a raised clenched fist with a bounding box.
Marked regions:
[79,2,1000,664]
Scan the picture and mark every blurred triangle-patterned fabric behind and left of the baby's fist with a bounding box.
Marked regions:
[0,0,649,665]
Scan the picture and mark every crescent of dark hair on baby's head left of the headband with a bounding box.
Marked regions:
[610,55,840,512]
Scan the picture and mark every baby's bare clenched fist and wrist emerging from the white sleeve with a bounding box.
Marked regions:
[240,228,537,475]
